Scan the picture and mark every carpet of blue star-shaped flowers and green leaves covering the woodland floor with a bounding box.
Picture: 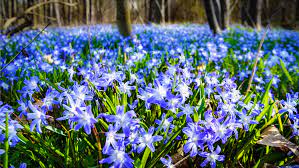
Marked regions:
[0,24,299,168]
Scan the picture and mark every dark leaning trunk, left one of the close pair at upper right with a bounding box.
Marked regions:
[203,0,221,34]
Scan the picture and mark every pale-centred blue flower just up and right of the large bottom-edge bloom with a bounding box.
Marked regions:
[137,127,163,153]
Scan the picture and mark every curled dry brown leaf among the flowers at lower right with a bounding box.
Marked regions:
[257,125,299,156]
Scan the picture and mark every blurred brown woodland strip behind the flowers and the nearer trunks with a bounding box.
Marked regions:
[0,0,299,32]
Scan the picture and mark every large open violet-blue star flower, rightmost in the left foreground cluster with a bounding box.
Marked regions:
[70,105,97,134]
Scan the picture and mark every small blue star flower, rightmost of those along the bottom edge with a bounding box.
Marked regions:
[199,146,224,168]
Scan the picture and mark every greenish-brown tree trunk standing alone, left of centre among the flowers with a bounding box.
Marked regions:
[116,0,132,37]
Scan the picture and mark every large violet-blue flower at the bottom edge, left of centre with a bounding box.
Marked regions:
[99,140,134,168]
